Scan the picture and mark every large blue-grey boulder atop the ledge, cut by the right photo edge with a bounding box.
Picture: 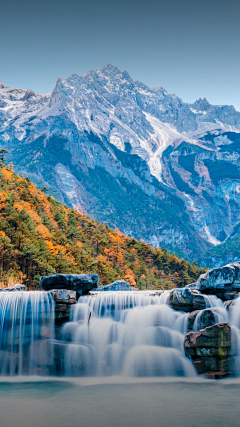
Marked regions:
[194,262,240,301]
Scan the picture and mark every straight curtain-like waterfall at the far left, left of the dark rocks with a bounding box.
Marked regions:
[0,291,54,375]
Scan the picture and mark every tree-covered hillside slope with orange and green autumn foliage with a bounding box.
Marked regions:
[0,166,203,289]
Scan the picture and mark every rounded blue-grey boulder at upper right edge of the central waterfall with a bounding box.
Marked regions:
[169,288,206,312]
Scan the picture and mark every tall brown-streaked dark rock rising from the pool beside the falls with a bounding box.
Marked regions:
[184,323,234,377]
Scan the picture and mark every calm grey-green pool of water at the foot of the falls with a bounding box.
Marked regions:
[0,378,240,427]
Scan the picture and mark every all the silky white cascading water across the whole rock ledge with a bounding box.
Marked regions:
[0,291,240,377]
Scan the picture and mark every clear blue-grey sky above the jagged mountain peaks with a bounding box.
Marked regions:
[0,0,240,111]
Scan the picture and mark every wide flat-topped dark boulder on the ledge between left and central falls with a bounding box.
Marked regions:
[40,274,98,295]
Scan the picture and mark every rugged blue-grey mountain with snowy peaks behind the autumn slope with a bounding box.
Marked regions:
[0,64,240,260]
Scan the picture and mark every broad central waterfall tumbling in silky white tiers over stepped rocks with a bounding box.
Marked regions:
[62,292,195,377]
